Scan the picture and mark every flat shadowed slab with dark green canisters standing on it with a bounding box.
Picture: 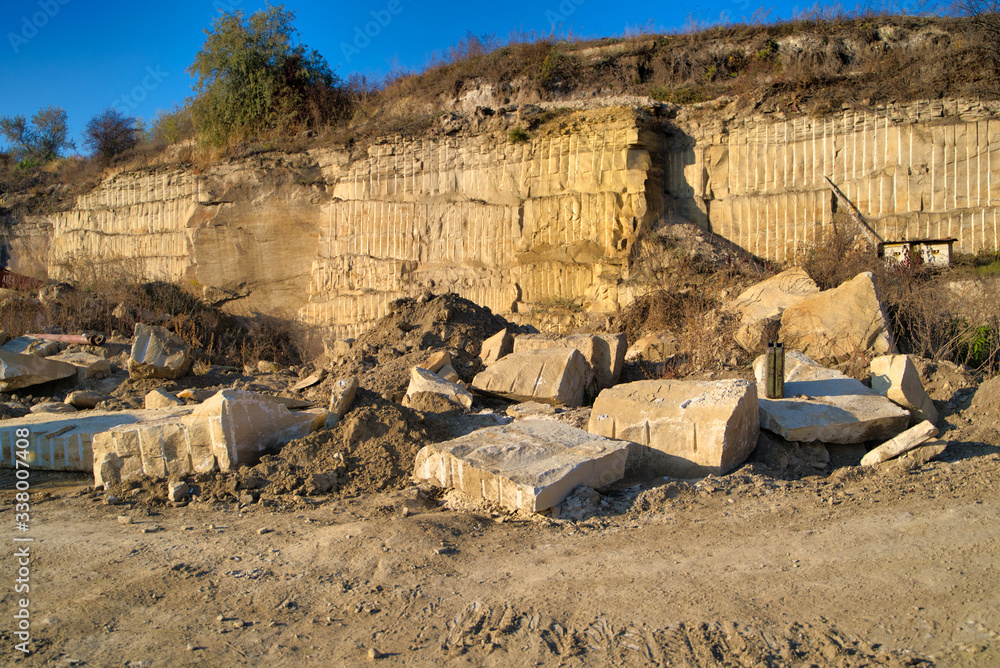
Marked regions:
[754,351,910,443]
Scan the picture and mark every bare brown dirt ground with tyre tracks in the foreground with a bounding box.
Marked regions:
[0,441,1000,666]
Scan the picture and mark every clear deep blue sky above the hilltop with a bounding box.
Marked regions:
[0,0,920,153]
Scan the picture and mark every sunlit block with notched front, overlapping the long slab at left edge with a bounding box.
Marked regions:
[93,390,327,486]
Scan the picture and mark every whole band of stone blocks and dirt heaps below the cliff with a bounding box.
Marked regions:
[0,269,988,520]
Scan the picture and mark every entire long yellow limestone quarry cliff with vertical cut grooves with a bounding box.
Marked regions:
[12,101,1000,336]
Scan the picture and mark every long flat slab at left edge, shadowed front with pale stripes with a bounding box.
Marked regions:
[0,410,190,473]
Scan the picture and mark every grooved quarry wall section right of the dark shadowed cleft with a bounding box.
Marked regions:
[665,100,1000,262]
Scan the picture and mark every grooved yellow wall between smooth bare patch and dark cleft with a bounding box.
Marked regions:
[300,111,651,336]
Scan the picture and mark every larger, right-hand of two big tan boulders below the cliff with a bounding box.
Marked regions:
[781,272,893,361]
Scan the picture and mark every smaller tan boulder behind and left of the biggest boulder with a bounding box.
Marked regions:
[727,267,819,352]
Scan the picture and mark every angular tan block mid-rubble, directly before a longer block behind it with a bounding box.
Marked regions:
[472,348,593,406]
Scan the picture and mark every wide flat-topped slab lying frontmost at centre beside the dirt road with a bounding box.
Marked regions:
[413,420,628,512]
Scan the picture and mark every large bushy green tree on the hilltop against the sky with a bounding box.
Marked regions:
[188,5,349,145]
